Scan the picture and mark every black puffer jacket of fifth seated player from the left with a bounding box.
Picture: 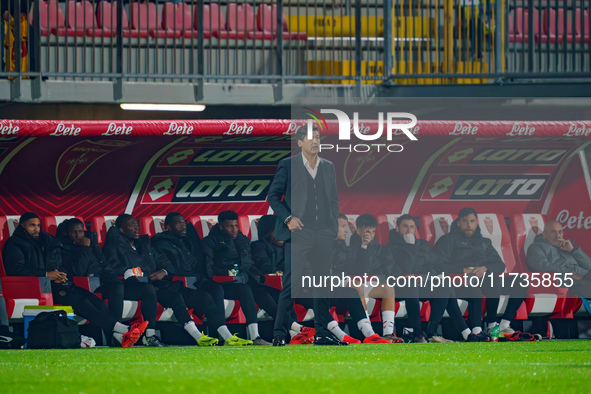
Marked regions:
[203,224,253,282]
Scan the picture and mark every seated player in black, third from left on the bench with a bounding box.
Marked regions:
[103,214,215,347]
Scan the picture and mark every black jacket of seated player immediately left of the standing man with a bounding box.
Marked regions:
[251,215,285,275]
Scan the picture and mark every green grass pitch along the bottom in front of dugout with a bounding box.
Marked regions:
[0,340,591,394]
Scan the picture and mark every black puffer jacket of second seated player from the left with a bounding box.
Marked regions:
[56,222,119,283]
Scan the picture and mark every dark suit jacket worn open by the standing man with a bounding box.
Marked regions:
[267,152,339,241]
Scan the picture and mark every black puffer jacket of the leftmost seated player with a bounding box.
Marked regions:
[2,226,61,279]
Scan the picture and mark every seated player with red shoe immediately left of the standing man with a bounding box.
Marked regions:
[248,215,316,345]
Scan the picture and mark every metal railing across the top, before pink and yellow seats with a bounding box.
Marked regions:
[0,0,591,99]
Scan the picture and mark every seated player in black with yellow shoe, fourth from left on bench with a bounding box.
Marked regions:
[151,212,252,346]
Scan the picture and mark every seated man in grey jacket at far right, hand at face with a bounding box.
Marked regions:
[527,220,591,299]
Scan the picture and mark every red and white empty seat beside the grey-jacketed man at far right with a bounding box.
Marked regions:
[510,214,574,318]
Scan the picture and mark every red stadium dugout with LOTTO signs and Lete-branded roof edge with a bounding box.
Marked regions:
[0,119,591,344]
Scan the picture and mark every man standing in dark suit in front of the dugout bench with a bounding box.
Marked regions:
[267,126,339,346]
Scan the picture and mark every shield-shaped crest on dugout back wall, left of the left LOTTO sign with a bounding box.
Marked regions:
[55,140,131,191]
